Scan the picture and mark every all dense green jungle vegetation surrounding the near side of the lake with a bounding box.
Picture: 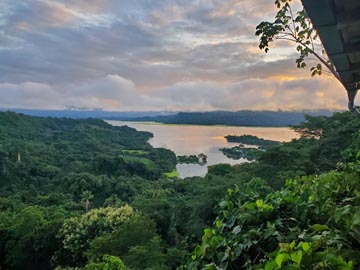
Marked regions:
[0,112,360,270]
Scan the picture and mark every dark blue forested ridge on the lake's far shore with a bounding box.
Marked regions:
[119,110,333,127]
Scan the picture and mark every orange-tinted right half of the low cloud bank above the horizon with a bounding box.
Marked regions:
[153,78,346,110]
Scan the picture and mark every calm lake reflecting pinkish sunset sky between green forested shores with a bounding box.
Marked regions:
[106,120,297,178]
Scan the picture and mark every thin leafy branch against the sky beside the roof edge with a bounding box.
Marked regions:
[255,0,360,116]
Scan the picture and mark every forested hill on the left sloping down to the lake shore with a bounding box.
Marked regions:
[0,112,176,195]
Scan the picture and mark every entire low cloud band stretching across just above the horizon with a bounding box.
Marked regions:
[0,75,346,111]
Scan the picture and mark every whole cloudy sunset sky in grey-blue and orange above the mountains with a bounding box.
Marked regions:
[0,0,347,111]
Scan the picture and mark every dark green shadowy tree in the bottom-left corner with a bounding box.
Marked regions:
[0,205,64,270]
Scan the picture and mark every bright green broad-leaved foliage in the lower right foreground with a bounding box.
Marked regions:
[186,162,360,270]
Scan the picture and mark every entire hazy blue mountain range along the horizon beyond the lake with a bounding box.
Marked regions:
[0,109,334,127]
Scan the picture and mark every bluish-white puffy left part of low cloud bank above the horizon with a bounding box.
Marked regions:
[0,75,141,108]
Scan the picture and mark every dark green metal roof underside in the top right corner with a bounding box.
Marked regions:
[302,0,360,91]
